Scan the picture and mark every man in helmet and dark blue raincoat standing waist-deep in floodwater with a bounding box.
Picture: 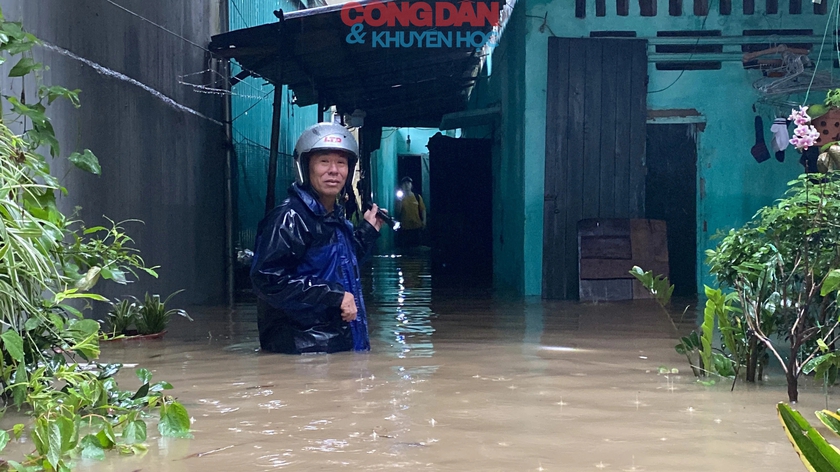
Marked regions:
[246,123,382,354]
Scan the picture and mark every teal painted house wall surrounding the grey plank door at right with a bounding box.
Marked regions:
[474,0,831,295]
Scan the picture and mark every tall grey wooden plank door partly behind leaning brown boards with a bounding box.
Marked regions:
[542,37,648,300]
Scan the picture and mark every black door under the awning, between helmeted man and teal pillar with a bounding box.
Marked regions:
[428,133,493,288]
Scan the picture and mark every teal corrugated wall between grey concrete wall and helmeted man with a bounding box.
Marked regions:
[229,0,318,249]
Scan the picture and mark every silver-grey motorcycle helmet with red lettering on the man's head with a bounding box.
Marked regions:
[294,123,359,187]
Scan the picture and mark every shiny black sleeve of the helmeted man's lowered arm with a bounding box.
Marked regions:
[251,206,344,310]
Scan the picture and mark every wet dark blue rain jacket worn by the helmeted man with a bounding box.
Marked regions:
[251,184,379,354]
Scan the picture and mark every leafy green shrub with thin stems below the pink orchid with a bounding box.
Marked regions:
[706,172,840,402]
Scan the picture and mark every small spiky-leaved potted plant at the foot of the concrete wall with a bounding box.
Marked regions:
[105,289,193,341]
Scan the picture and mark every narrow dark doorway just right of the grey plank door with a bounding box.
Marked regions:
[645,124,697,297]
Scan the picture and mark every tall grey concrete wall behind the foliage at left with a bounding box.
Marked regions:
[0,0,226,306]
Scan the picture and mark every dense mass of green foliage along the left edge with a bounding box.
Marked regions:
[0,9,190,471]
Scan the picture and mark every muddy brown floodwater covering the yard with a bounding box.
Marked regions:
[14,256,837,472]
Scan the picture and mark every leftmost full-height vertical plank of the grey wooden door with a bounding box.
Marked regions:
[543,37,577,298]
